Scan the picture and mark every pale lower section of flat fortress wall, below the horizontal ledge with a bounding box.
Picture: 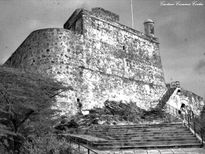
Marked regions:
[82,69,167,109]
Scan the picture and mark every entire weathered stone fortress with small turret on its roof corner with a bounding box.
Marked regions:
[5,8,204,115]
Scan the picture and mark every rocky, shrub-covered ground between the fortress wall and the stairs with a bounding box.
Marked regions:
[55,100,181,133]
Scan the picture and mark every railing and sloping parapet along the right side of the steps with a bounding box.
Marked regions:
[165,103,205,146]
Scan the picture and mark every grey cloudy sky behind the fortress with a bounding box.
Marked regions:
[0,0,205,98]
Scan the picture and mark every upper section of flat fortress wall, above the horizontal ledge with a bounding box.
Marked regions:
[83,10,165,83]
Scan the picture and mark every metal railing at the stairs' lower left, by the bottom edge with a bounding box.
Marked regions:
[64,135,98,154]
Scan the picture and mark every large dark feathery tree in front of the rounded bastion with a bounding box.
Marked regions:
[0,66,73,154]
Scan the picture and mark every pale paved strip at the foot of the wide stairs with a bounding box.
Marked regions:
[95,148,205,154]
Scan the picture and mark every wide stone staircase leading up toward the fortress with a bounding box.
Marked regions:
[67,123,201,150]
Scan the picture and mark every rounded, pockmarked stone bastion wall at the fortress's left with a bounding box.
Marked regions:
[6,28,83,114]
